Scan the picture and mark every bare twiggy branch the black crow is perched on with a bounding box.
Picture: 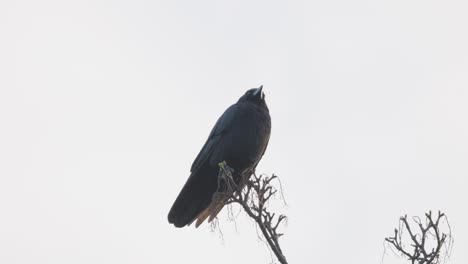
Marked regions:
[216,162,288,264]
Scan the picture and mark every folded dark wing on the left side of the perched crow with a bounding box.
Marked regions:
[190,104,238,172]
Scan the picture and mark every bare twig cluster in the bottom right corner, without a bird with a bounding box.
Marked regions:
[385,211,453,264]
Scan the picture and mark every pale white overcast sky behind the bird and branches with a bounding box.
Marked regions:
[0,0,468,264]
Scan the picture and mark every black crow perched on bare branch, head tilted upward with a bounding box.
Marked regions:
[168,86,271,227]
